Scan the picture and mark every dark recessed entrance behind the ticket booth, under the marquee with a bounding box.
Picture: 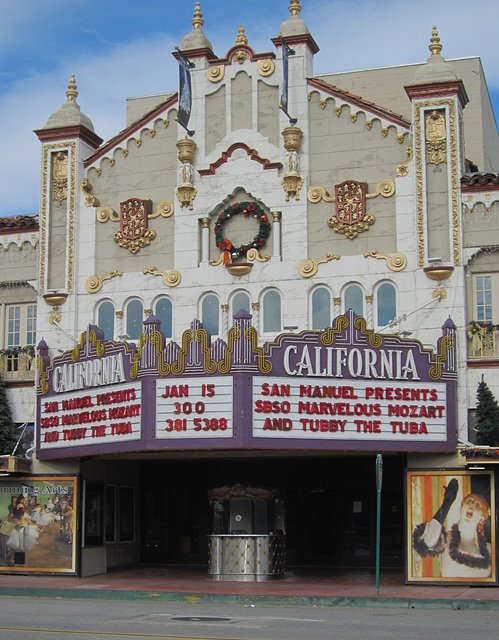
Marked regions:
[141,455,405,567]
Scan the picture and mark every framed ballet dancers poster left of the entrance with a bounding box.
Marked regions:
[0,476,77,574]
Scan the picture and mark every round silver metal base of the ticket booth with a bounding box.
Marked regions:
[208,534,286,582]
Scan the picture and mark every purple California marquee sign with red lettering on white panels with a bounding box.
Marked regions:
[37,311,457,458]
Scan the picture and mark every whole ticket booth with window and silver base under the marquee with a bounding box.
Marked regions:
[208,484,286,582]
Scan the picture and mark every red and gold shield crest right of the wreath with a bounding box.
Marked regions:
[328,180,375,240]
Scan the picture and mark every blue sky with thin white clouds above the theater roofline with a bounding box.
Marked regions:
[0,0,499,216]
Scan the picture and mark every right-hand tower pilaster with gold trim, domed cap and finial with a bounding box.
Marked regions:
[405,27,468,267]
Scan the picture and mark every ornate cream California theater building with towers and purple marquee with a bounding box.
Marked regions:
[0,0,499,582]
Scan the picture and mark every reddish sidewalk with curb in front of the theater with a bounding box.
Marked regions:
[0,567,499,610]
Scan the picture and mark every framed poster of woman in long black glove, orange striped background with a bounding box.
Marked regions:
[406,470,497,584]
